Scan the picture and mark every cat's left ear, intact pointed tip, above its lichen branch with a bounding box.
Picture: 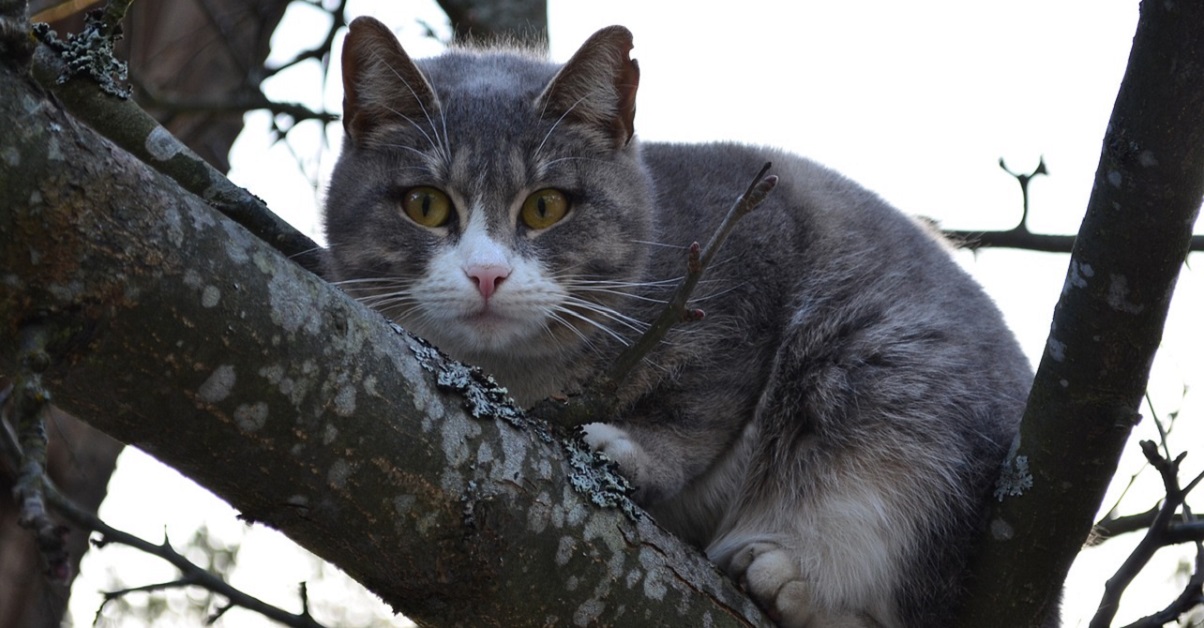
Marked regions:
[343,17,439,144]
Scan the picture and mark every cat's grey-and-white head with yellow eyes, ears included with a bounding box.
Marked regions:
[325,18,653,375]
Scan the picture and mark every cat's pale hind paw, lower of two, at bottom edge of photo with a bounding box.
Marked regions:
[728,541,826,628]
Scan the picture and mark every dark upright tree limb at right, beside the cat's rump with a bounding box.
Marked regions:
[961,1,1204,627]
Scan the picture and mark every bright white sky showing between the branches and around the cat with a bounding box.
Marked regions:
[72,0,1204,627]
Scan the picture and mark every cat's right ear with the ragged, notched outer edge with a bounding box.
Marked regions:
[537,26,639,148]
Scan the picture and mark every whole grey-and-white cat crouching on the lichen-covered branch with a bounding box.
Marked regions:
[325,18,1032,627]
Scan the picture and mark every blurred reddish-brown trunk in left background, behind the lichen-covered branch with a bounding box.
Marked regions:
[0,0,288,628]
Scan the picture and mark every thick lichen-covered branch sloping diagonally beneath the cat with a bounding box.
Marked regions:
[0,59,766,626]
